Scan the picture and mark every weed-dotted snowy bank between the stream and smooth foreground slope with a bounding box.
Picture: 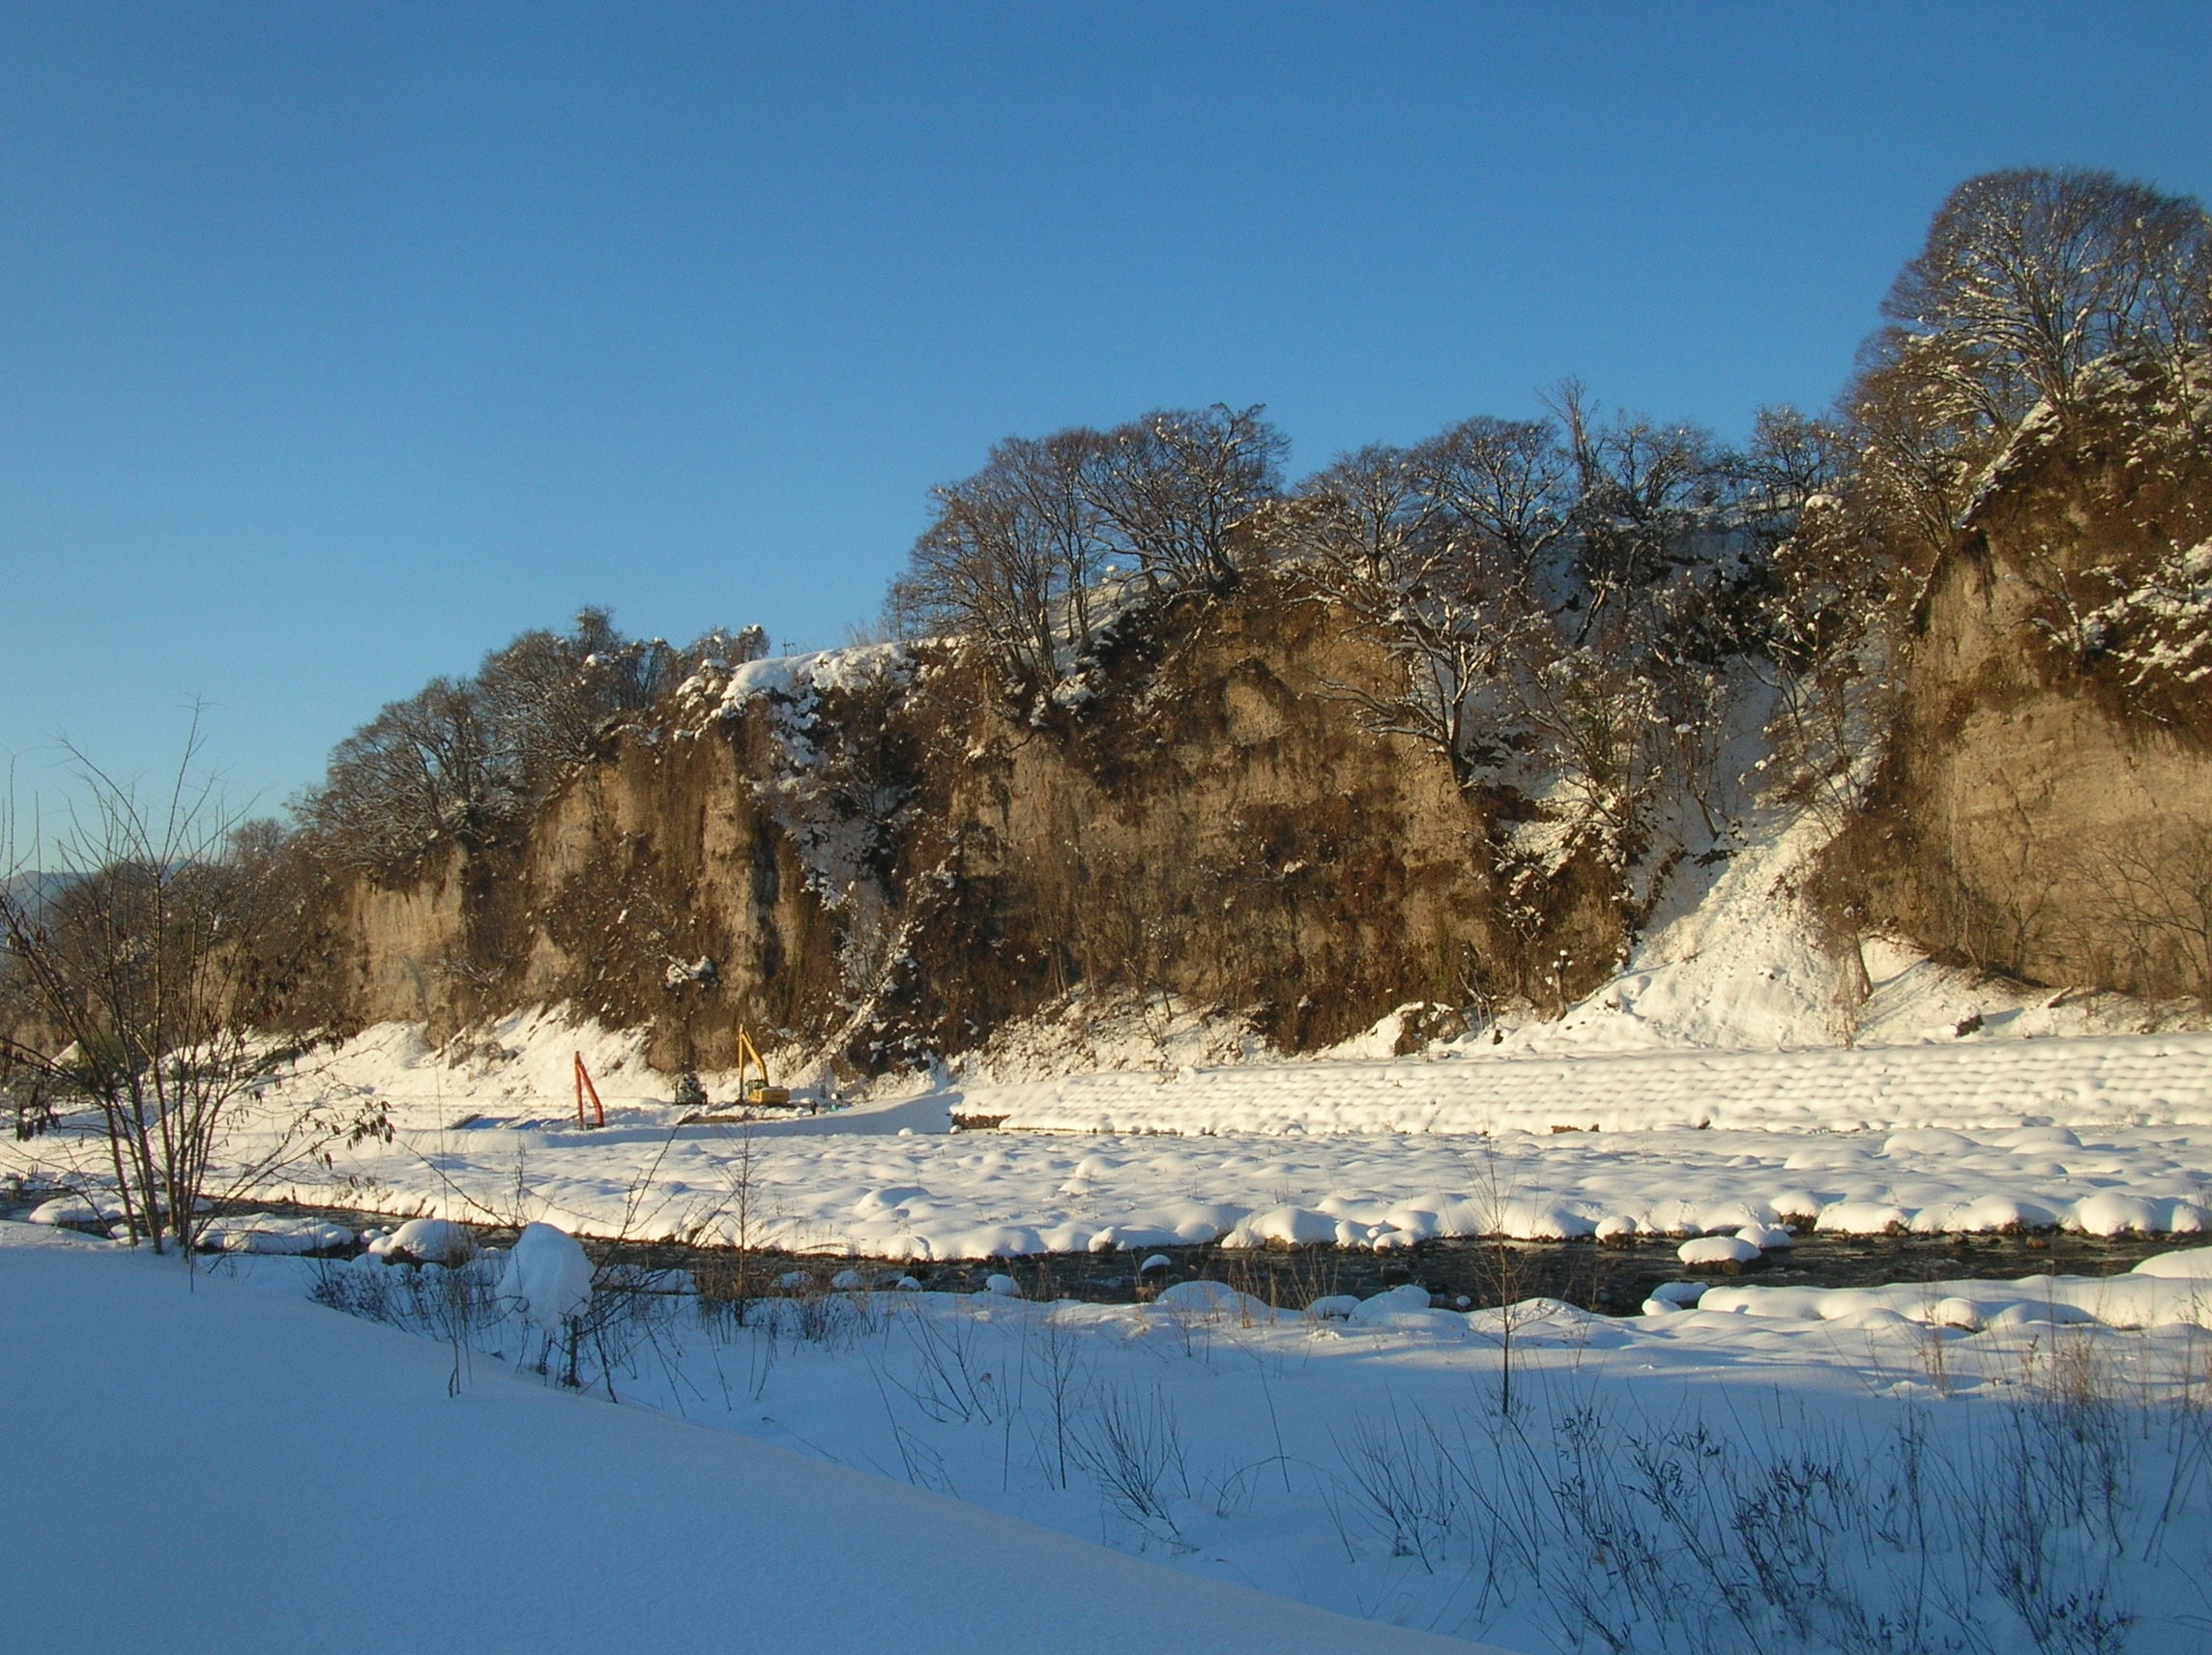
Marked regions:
[203,1248,2212,1655]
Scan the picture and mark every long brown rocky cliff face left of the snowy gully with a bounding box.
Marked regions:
[307,582,1623,1071]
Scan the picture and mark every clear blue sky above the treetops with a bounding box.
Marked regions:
[0,0,2212,827]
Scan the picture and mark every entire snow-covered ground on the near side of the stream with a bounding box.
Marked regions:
[25,1226,2212,1655]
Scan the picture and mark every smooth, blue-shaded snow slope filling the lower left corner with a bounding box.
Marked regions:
[0,1226,1469,1655]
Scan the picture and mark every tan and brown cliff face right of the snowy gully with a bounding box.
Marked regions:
[1843,361,2212,998]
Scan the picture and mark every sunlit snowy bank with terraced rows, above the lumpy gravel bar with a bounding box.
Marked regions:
[977,1035,2212,1133]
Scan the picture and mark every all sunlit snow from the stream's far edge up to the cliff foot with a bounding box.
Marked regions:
[13,787,2212,1259]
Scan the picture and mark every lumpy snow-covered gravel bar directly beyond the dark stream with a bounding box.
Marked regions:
[272,1106,2212,1259]
